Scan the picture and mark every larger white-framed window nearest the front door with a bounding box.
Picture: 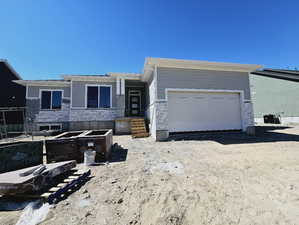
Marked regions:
[87,85,112,108]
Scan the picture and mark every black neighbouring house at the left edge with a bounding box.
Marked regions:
[0,59,26,126]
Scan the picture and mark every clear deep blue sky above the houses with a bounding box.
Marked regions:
[0,0,299,79]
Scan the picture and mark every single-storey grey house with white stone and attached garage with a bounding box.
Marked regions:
[16,58,260,140]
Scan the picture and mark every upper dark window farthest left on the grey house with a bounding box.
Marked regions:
[41,91,62,109]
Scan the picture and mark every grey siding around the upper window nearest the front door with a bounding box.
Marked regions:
[72,81,116,108]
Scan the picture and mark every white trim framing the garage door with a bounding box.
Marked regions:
[165,88,244,131]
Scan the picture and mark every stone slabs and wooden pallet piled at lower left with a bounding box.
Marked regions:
[0,160,90,204]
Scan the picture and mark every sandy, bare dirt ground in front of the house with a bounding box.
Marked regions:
[0,127,299,225]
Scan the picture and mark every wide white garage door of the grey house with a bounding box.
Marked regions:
[168,92,242,132]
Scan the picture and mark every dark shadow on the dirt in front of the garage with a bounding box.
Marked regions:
[168,126,299,145]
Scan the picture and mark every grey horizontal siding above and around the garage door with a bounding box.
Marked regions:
[157,68,250,100]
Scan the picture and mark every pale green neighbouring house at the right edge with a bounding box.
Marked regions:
[250,69,299,124]
